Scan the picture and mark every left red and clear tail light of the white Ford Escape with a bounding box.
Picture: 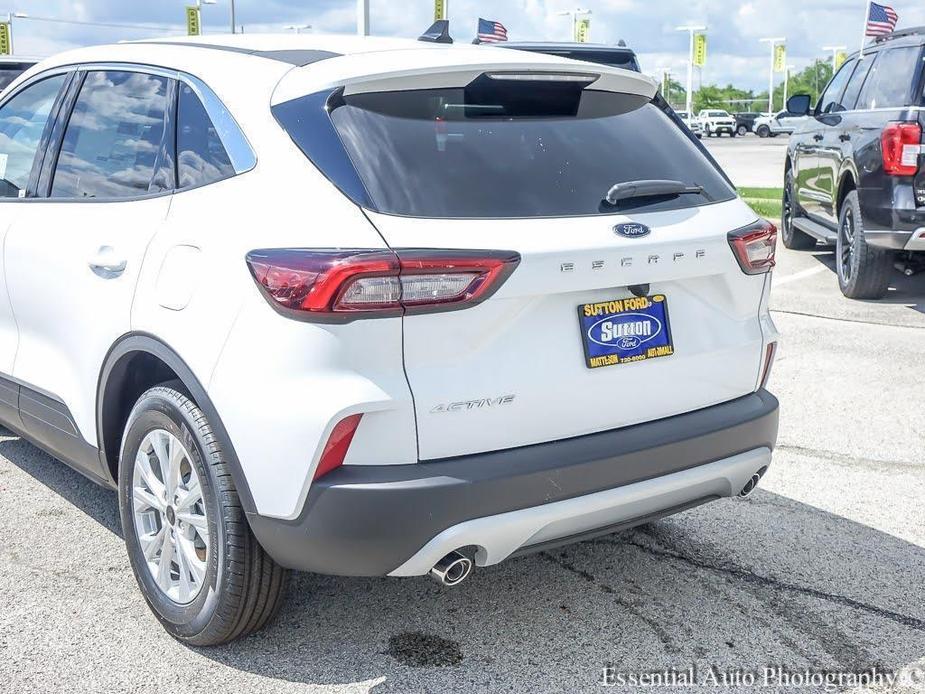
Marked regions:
[247,249,520,321]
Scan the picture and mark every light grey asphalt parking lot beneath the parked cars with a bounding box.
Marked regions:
[0,138,925,694]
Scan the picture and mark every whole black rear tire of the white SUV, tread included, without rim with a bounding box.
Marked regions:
[119,382,288,646]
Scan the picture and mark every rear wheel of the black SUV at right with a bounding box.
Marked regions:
[835,190,893,299]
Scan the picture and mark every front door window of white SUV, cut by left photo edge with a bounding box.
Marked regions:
[0,75,66,198]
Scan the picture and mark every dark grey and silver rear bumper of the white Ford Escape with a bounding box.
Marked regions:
[249,391,778,576]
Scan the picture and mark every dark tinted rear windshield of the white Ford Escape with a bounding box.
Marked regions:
[276,80,735,218]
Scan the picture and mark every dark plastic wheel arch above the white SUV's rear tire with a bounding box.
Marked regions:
[96,333,255,512]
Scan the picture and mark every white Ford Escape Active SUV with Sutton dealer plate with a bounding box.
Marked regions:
[0,36,778,644]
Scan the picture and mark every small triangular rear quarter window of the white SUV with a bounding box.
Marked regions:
[177,84,234,188]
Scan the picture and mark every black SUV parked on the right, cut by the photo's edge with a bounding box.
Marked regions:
[781,27,925,299]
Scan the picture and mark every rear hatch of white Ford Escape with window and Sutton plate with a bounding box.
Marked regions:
[274,50,767,460]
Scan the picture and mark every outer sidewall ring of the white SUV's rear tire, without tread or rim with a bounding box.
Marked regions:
[119,388,225,637]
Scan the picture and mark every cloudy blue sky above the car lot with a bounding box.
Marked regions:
[8,0,925,90]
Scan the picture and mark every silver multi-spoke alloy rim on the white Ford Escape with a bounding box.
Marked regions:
[132,429,211,605]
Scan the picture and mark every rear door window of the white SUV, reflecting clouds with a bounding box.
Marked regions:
[51,71,169,198]
